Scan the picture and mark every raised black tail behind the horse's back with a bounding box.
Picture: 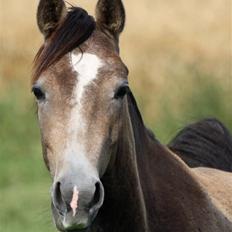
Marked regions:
[168,119,232,171]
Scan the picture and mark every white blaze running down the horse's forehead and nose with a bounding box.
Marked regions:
[59,53,103,176]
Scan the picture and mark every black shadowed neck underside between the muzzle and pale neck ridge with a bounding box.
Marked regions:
[93,94,148,232]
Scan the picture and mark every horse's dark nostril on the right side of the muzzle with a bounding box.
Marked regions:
[90,182,104,213]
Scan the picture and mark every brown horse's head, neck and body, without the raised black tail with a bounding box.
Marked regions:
[32,0,232,232]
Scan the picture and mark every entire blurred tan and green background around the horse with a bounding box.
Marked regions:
[0,0,232,232]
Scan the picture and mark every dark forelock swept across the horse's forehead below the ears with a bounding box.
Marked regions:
[33,7,96,81]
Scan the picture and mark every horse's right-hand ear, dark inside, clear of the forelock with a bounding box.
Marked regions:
[96,0,126,38]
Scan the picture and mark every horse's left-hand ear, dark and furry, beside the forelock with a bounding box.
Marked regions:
[37,0,67,39]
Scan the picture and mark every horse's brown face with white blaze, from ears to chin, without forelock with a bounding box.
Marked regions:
[33,1,128,231]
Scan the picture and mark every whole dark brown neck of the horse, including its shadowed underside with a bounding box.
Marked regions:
[93,95,230,232]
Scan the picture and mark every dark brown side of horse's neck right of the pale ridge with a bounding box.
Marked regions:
[125,95,216,232]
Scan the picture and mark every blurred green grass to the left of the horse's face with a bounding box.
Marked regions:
[0,83,55,232]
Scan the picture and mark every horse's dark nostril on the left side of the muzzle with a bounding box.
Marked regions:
[53,182,67,216]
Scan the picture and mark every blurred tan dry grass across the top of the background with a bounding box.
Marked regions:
[1,0,231,82]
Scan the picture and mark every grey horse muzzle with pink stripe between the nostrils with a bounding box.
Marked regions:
[52,176,104,232]
